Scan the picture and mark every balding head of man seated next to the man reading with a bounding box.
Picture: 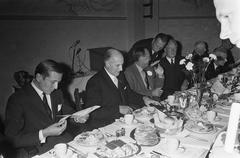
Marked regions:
[104,48,124,77]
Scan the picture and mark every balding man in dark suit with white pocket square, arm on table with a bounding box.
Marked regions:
[85,49,159,129]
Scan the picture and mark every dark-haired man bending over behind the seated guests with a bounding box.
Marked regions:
[127,33,170,65]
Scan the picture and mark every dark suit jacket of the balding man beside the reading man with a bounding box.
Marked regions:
[85,69,144,130]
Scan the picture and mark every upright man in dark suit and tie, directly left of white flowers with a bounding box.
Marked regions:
[160,39,188,99]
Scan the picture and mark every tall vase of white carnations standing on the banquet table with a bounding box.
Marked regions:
[179,54,217,105]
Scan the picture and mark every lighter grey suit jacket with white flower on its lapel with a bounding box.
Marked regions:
[124,64,163,97]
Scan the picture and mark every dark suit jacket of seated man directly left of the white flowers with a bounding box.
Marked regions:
[160,57,185,99]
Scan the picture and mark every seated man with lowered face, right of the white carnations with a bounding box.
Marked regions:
[205,48,229,80]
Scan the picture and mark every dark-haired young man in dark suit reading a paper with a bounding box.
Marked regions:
[5,60,88,157]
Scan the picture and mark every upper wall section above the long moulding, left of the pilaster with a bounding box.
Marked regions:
[0,0,126,17]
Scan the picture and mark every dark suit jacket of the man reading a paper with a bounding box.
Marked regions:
[5,84,74,153]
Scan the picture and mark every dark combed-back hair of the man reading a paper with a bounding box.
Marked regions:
[34,59,63,77]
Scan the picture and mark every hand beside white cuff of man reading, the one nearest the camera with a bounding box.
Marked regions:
[42,120,67,138]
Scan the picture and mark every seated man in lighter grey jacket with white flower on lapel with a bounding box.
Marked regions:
[124,47,164,97]
